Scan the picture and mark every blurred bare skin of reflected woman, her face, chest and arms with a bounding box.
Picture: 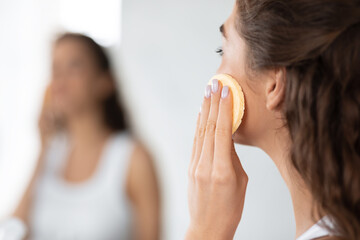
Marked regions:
[14,39,160,240]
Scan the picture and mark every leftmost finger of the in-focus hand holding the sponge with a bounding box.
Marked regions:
[190,85,211,175]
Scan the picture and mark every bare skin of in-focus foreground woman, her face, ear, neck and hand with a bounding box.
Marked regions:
[186,5,338,240]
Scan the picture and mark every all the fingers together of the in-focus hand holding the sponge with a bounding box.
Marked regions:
[193,80,244,183]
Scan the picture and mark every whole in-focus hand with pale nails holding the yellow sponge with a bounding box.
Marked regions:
[186,80,248,240]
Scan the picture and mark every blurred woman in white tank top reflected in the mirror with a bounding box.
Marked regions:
[14,33,160,240]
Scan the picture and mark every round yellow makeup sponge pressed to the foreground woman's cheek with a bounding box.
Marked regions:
[209,74,245,134]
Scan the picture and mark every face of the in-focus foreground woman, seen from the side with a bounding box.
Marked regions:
[217,5,272,145]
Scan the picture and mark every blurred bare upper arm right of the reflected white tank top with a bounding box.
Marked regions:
[127,143,160,240]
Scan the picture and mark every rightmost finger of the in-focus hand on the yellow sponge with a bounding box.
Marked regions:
[213,86,233,175]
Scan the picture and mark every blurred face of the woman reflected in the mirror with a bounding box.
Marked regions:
[51,39,107,117]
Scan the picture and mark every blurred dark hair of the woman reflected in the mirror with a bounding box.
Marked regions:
[56,33,129,131]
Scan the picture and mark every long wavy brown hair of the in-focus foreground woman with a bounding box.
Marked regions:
[236,0,360,240]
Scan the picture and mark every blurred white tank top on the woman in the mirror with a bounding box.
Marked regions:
[29,131,133,240]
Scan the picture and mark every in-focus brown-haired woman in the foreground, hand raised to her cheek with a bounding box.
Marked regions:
[186,0,360,240]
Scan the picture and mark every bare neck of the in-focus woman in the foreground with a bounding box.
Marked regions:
[260,124,315,237]
